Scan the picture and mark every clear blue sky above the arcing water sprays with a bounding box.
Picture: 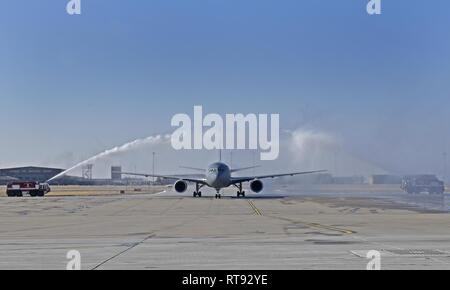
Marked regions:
[0,0,450,177]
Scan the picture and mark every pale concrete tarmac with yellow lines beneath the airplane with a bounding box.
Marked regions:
[0,189,450,270]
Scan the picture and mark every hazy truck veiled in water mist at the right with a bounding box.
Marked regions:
[401,175,445,195]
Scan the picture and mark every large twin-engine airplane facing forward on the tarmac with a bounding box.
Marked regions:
[121,162,326,199]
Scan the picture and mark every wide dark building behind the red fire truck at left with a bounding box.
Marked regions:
[0,166,64,185]
